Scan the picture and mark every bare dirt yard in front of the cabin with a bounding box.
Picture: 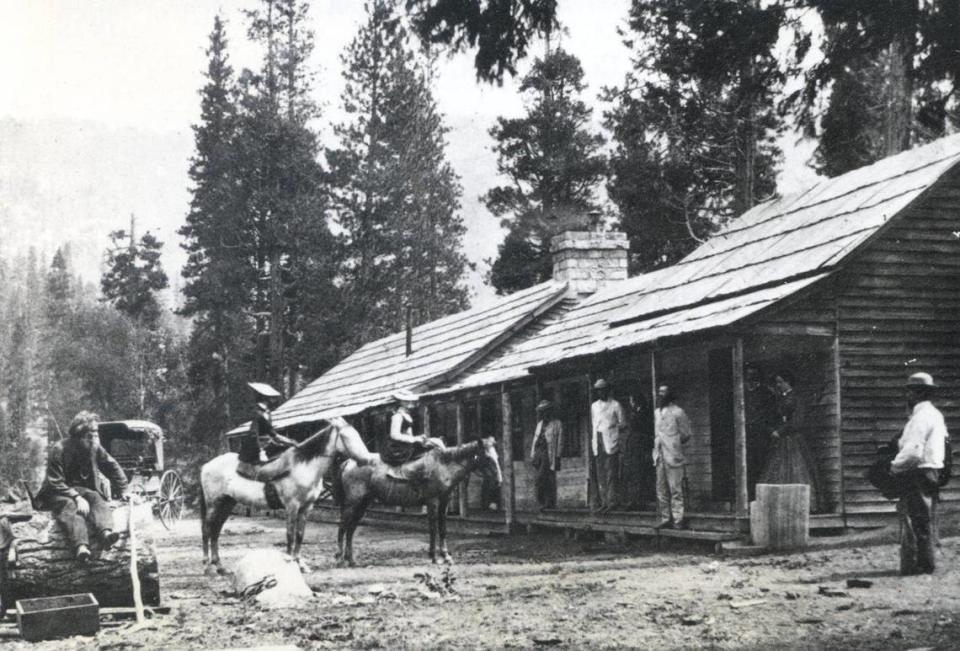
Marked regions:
[7,517,960,650]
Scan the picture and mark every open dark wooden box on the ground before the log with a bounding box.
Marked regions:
[17,593,100,642]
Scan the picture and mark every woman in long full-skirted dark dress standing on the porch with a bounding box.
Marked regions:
[758,371,821,512]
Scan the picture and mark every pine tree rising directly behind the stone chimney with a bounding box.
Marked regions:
[483,49,605,294]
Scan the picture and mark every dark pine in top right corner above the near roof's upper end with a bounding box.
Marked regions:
[786,0,960,175]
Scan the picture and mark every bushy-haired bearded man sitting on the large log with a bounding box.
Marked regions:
[37,411,127,562]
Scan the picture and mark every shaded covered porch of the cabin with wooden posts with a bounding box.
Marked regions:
[480,328,845,540]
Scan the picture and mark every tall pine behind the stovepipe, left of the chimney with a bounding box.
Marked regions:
[327,0,467,348]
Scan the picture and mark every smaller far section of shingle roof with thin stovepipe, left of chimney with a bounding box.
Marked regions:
[256,282,566,431]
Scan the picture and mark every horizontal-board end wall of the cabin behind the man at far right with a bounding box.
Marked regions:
[839,176,960,516]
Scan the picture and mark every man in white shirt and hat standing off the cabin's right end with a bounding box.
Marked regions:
[890,373,949,574]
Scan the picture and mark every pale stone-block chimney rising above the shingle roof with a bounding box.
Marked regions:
[550,231,630,295]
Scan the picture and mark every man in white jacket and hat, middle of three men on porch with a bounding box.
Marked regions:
[590,378,629,513]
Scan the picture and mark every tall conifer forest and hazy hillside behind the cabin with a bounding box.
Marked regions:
[0,0,960,488]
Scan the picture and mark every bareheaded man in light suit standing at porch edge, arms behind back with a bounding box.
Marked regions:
[653,384,691,529]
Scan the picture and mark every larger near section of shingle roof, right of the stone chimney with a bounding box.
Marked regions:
[426,135,960,393]
